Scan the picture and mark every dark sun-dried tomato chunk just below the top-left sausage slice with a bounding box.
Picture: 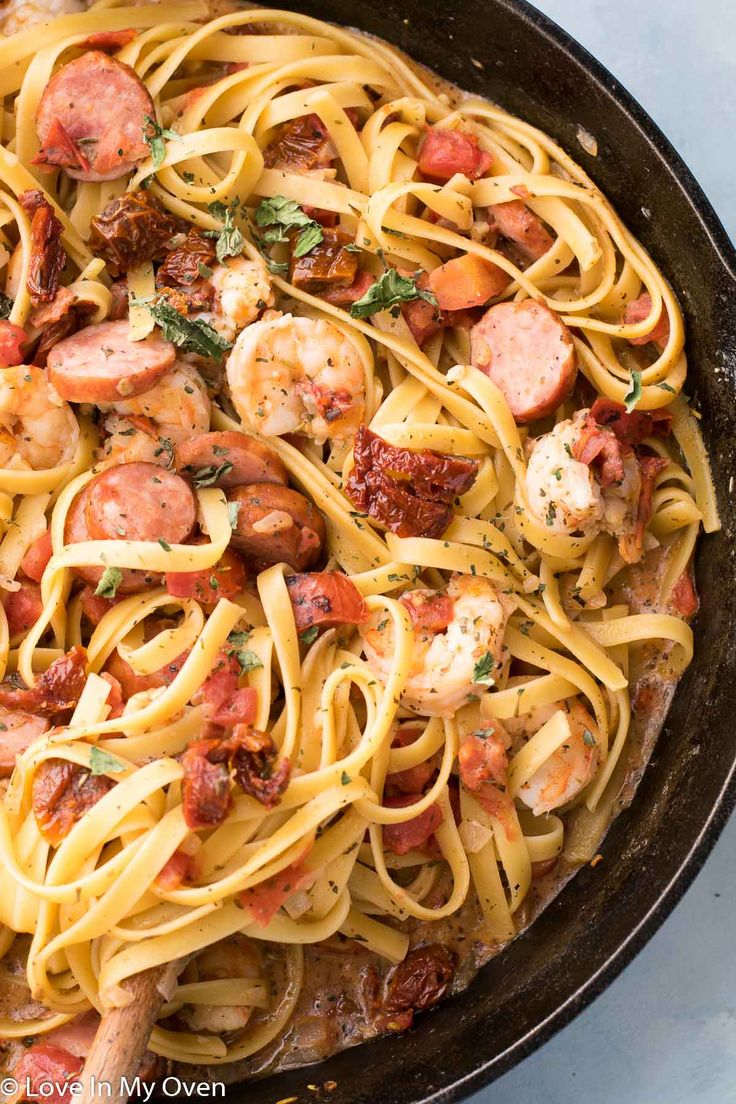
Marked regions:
[89,191,188,276]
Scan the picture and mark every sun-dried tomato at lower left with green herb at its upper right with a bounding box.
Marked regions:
[32,760,115,847]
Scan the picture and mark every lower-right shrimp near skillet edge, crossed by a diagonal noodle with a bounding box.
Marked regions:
[504,699,600,816]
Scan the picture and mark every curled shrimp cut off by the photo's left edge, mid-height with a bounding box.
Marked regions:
[0,364,79,471]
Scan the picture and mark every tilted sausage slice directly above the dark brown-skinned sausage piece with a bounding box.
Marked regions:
[175,429,288,490]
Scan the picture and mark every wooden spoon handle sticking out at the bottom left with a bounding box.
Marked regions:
[74,962,182,1104]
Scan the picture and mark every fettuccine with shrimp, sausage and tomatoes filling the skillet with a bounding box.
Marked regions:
[0,0,719,1075]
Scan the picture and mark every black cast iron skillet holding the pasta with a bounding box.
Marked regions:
[228,0,736,1104]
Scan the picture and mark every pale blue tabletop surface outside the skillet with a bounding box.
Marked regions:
[472,0,736,1104]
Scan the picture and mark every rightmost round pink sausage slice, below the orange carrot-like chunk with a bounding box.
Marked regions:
[470,299,577,422]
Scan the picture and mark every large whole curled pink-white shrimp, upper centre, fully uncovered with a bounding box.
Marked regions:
[227,312,365,444]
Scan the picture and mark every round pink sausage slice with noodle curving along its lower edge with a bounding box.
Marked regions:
[85,461,196,544]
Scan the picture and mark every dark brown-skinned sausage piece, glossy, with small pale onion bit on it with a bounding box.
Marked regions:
[227,484,326,571]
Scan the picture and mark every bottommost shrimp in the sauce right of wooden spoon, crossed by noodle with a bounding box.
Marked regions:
[179,935,260,1034]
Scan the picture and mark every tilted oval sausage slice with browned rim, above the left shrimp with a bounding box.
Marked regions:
[46,320,177,403]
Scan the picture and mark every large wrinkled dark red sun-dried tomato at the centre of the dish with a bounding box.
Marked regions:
[345,426,478,537]
